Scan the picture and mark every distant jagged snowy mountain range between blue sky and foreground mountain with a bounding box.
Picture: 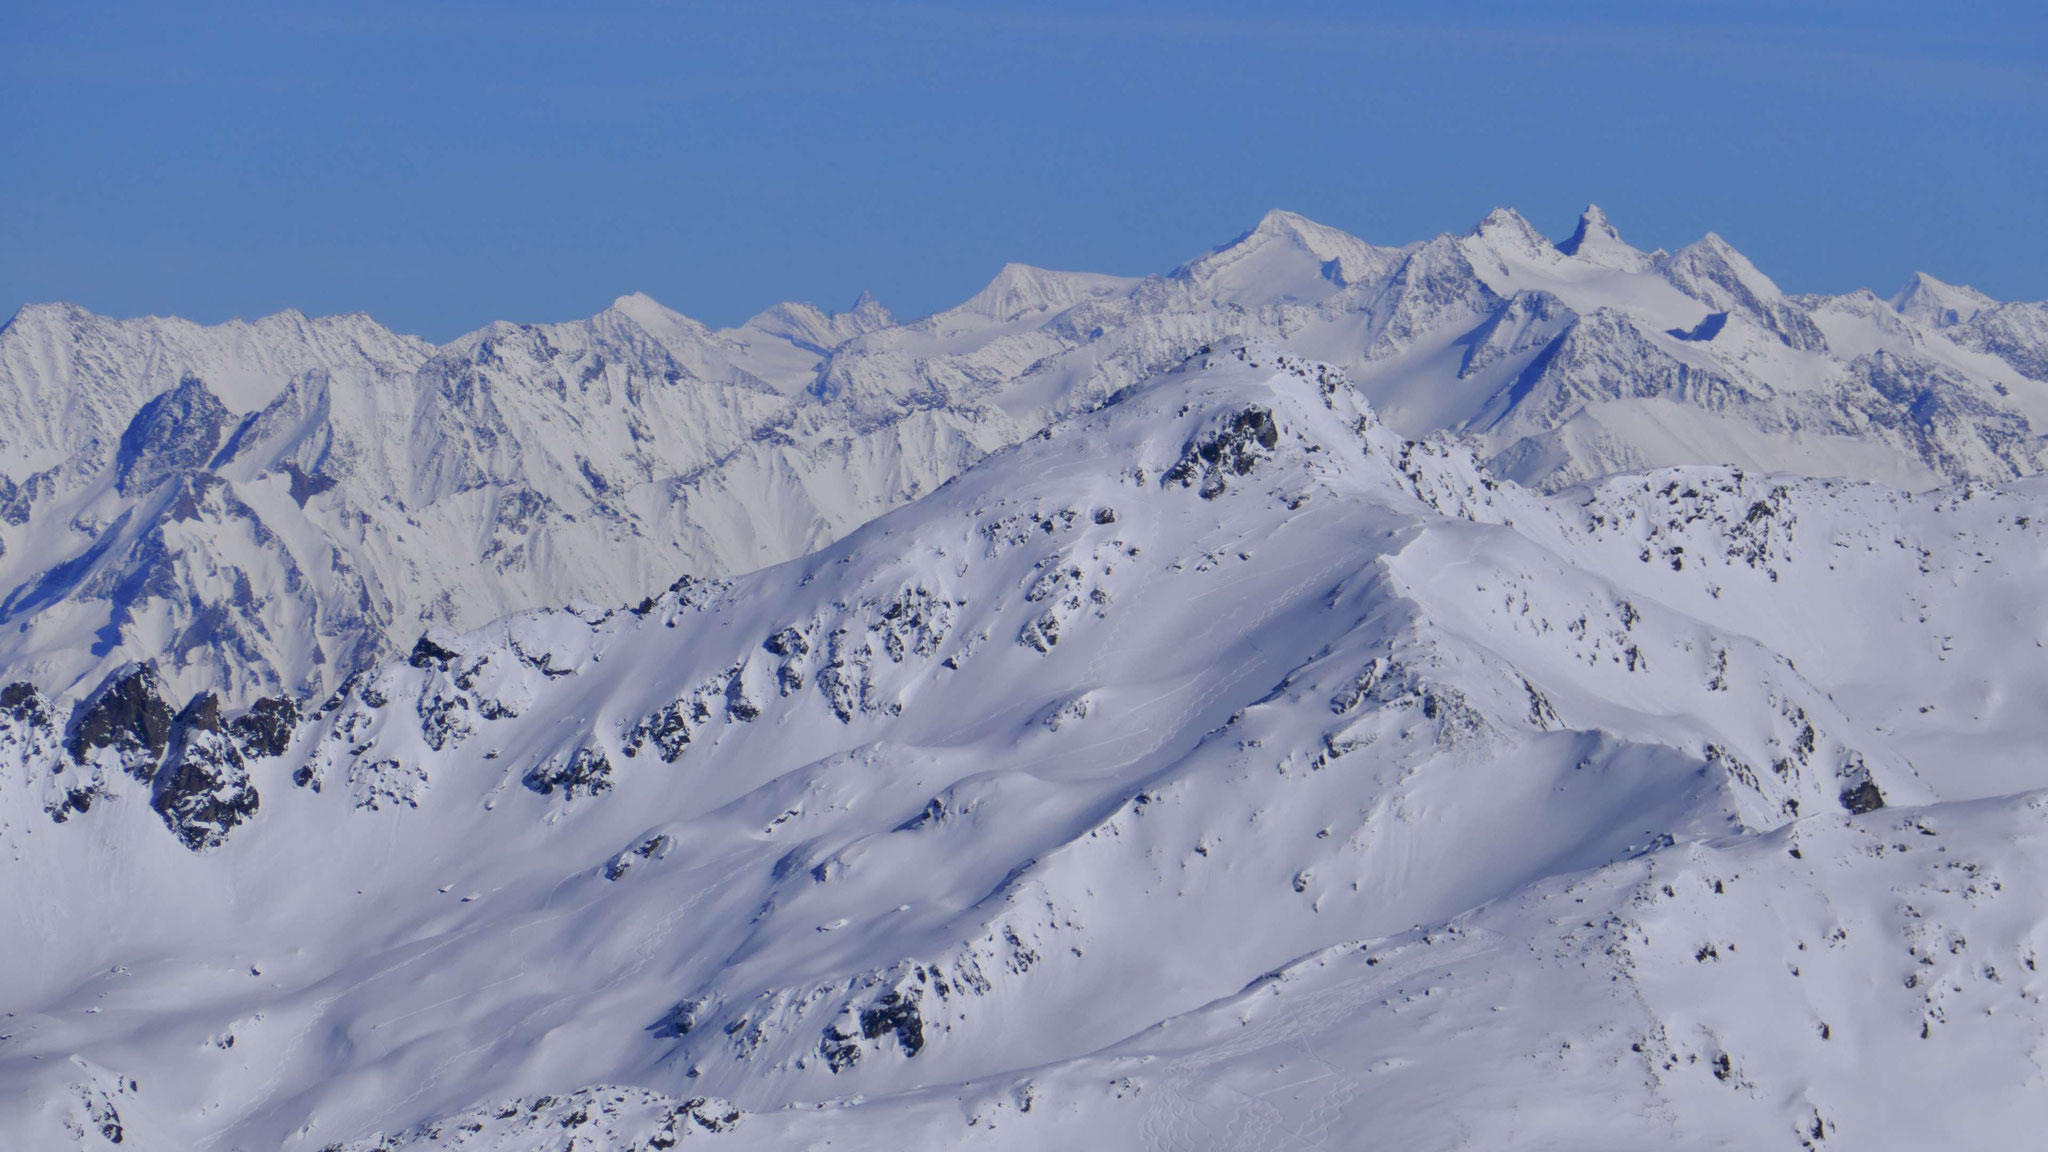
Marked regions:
[0,209,2048,705]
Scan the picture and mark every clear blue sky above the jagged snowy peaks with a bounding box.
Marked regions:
[0,0,2048,340]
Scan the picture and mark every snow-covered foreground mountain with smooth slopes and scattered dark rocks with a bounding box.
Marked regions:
[0,342,2048,1152]
